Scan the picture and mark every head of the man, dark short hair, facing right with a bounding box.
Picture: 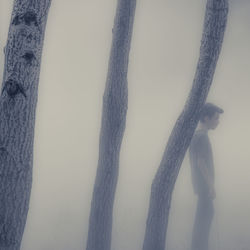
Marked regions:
[200,103,224,129]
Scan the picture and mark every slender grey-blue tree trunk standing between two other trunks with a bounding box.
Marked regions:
[87,0,136,250]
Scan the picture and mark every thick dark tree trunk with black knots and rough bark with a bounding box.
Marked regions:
[0,0,51,250]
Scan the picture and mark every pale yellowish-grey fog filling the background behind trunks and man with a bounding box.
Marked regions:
[0,0,250,250]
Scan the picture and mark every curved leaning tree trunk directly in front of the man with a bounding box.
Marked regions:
[143,0,228,250]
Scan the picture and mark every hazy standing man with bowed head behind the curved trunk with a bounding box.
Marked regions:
[189,103,223,250]
